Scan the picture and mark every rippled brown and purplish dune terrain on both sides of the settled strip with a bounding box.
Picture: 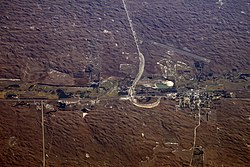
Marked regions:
[0,0,250,167]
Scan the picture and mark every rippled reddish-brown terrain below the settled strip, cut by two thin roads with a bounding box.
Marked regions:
[0,100,250,167]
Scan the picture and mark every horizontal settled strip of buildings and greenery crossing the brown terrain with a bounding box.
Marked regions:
[0,61,250,112]
